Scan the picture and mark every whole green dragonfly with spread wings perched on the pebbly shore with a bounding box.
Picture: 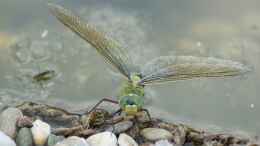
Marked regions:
[48,3,250,120]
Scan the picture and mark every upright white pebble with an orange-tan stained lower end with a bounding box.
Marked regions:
[31,120,51,146]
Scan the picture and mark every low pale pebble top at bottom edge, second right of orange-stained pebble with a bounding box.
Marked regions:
[55,136,89,146]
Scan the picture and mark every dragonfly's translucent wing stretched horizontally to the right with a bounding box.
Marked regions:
[140,56,250,85]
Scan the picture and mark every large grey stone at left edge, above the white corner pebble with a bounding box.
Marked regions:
[0,108,23,138]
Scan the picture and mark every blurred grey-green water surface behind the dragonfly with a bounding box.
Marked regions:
[0,0,260,135]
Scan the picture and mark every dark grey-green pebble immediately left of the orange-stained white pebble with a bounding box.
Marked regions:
[16,128,33,146]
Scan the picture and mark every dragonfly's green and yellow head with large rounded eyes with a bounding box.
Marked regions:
[119,94,143,115]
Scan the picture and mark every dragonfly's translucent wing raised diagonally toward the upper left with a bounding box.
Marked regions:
[48,4,136,79]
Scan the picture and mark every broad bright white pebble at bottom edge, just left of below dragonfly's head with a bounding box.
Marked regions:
[87,132,117,146]
